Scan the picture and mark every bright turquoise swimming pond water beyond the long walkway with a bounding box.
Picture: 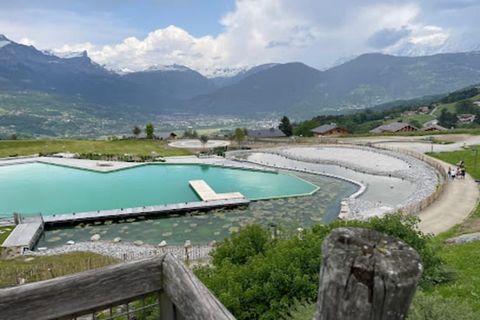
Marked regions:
[0,163,317,216]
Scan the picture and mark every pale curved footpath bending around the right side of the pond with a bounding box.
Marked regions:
[376,143,479,234]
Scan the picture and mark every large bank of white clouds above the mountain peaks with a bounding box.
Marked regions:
[0,0,478,74]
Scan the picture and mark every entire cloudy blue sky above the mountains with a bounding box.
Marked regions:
[0,0,480,76]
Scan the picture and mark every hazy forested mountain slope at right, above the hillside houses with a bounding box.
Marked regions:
[305,53,480,111]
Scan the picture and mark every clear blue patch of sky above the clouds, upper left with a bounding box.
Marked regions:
[0,0,235,44]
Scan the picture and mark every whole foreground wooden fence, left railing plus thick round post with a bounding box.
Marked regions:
[0,228,422,320]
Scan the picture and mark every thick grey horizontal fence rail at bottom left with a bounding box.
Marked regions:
[0,256,164,320]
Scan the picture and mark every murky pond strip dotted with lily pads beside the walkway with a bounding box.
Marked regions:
[37,174,357,247]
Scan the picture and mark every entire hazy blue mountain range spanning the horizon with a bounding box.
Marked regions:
[0,35,480,126]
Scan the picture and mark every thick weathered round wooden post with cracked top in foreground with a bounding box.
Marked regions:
[315,228,422,320]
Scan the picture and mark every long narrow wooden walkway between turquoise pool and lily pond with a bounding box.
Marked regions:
[43,197,250,224]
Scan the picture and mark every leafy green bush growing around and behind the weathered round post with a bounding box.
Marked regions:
[195,214,447,320]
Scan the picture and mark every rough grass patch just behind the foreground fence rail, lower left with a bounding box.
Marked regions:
[0,252,117,287]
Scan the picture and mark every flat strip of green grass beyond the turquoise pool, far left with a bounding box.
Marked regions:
[0,140,190,157]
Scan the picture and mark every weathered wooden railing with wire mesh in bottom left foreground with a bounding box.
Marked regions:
[0,253,235,320]
